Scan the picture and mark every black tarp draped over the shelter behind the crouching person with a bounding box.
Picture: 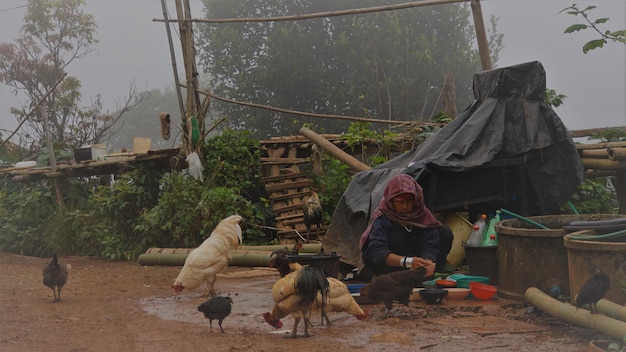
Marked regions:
[323,61,584,267]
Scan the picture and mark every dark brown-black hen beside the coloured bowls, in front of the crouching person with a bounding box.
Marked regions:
[361,267,426,317]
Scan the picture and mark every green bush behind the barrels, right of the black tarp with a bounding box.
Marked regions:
[561,177,619,214]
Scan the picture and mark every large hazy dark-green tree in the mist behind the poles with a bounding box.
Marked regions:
[196,0,501,138]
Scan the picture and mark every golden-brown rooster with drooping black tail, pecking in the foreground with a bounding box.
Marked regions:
[263,265,329,337]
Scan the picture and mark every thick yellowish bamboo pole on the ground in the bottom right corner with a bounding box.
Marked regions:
[525,287,626,341]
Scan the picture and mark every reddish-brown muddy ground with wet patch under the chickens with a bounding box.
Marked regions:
[0,253,607,352]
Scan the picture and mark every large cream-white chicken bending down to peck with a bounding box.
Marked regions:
[172,215,243,297]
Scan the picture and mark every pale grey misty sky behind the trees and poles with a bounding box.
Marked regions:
[0,0,626,140]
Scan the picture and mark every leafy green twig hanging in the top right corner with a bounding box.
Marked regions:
[561,4,626,54]
